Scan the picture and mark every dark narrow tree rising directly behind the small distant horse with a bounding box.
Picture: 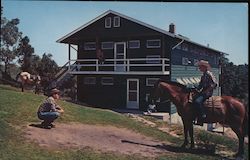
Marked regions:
[17,36,34,74]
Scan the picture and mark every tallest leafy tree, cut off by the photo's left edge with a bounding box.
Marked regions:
[0,7,22,73]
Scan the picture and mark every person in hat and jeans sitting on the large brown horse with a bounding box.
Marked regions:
[193,60,217,122]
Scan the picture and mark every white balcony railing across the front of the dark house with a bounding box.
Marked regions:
[68,58,169,74]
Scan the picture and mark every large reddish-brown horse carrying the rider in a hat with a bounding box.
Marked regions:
[150,81,248,156]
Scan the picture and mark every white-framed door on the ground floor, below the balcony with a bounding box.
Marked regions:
[127,79,139,109]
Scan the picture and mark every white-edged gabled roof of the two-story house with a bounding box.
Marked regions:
[56,10,227,55]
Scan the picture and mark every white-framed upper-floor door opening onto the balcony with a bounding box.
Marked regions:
[114,42,126,72]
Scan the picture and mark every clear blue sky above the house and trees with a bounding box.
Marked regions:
[1,0,249,66]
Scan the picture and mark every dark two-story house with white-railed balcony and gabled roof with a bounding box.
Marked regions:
[57,10,225,113]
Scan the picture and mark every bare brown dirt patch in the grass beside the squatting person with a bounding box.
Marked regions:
[25,123,170,157]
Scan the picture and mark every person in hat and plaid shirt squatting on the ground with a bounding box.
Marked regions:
[37,88,64,129]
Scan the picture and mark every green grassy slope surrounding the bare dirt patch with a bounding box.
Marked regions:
[0,85,248,160]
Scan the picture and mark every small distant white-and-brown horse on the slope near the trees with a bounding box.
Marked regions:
[16,72,41,94]
